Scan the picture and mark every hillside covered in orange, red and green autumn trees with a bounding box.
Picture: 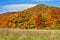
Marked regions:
[0,4,60,29]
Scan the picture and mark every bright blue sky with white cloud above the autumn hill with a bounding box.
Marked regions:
[0,0,60,14]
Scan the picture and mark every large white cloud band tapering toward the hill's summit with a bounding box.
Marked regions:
[0,4,36,13]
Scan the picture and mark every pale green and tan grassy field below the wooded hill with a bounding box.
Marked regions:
[0,29,60,40]
